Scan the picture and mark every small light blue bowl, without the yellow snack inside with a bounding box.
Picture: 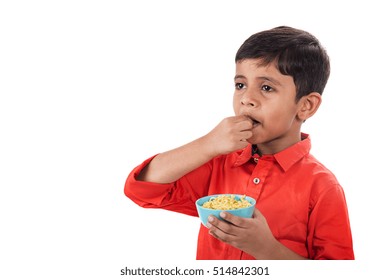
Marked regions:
[195,194,256,226]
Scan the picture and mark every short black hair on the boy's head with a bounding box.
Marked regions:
[235,26,330,101]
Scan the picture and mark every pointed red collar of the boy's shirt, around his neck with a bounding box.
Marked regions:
[233,133,311,172]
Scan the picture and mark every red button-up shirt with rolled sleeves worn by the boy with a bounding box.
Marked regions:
[125,134,354,260]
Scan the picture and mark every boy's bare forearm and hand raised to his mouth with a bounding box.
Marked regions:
[137,116,252,183]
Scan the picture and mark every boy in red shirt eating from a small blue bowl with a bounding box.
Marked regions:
[125,26,354,259]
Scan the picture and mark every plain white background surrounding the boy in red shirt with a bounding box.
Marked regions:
[0,0,390,279]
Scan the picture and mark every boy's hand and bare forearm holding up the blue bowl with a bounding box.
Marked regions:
[208,209,279,259]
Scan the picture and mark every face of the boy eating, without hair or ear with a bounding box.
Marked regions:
[233,59,302,154]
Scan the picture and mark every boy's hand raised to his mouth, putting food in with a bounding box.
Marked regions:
[205,116,253,155]
